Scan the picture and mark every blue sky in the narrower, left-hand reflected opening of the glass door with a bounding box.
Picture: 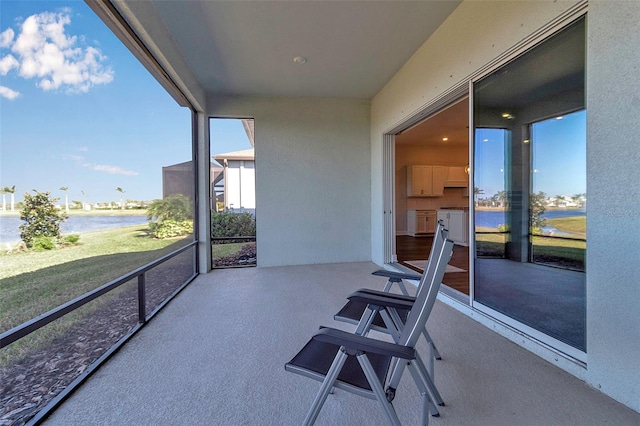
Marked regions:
[473,129,506,198]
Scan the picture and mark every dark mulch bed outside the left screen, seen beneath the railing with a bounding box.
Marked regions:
[0,261,193,426]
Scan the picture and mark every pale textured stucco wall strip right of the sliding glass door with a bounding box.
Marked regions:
[586,1,640,411]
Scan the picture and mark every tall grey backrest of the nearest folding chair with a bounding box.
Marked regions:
[398,227,453,347]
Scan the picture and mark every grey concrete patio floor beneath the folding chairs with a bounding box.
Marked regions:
[45,263,640,426]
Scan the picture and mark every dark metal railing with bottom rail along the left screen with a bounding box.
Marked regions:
[0,241,198,425]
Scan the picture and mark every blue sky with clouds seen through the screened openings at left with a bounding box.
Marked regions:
[0,0,250,202]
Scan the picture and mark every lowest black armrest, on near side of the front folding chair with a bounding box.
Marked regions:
[313,328,416,360]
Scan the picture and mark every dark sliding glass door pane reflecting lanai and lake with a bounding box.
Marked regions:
[473,19,586,355]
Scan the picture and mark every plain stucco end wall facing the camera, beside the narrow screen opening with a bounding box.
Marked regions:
[208,97,371,266]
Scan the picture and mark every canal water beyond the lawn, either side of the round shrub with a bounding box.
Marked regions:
[0,216,148,243]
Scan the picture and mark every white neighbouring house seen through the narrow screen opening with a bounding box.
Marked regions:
[213,148,256,213]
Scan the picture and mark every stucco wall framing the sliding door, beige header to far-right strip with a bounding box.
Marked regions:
[371,1,640,411]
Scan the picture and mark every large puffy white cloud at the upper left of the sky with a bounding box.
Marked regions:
[0,12,114,93]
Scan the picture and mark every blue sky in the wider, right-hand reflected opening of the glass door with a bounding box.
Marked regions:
[531,110,587,197]
